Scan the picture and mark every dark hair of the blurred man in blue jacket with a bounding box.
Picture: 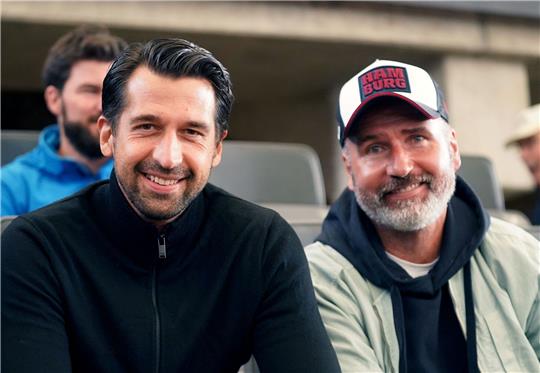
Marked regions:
[42,25,127,90]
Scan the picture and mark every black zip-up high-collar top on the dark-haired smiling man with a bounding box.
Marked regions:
[1,172,339,373]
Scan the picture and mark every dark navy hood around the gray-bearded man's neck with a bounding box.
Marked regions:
[317,176,489,294]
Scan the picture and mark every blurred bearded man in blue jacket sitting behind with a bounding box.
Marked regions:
[0,26,127,216]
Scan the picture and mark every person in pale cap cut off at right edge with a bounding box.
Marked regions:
[506,104,540,225]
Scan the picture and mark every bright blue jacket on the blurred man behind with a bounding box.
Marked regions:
[0,125,113,216]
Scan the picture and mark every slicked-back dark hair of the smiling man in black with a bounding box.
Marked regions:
[102,38,234,138]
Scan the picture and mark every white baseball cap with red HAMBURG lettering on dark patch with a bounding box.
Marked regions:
[338,60,448,146]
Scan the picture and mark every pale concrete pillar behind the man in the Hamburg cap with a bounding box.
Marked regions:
[443,55,532,189]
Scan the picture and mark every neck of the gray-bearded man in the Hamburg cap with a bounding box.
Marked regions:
[375,209,446,264]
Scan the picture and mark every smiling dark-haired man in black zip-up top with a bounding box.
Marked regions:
[2,39,339,373]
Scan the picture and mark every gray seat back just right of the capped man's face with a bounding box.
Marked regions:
[458,155,504,210]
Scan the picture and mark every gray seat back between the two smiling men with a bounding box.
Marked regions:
[210,141,326,206]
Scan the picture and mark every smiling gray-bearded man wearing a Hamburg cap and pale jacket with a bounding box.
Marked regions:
[306,60,540,372]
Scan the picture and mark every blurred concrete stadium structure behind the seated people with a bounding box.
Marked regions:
[1,1,540,203]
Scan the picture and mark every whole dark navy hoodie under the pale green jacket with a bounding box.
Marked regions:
[317,176,489,373]
